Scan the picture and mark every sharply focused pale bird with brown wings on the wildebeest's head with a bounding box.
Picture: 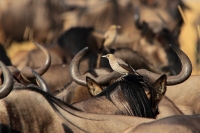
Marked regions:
[102,54,135,75]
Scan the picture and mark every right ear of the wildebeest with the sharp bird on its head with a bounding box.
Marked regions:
[153,74,167,104]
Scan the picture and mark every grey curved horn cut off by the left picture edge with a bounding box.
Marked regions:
[0,61,14,99]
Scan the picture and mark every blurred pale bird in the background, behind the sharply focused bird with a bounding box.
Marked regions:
[103,25,121,47]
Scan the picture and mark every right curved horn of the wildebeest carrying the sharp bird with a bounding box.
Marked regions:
[136,44,192,86]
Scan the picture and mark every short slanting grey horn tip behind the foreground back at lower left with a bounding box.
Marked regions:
[32,70,49,92]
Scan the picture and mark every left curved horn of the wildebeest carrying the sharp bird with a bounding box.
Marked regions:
[70,47,121,86]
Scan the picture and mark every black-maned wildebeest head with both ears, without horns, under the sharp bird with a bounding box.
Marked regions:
[76,75,166,118]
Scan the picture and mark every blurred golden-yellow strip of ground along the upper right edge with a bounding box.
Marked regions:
[179,0,200,75]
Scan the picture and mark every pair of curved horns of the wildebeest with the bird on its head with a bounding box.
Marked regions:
[70,45,192,86]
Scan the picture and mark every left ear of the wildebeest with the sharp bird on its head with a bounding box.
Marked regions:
[86,76,103,96]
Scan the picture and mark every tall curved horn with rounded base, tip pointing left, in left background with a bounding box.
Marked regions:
[21,42,51,81]
